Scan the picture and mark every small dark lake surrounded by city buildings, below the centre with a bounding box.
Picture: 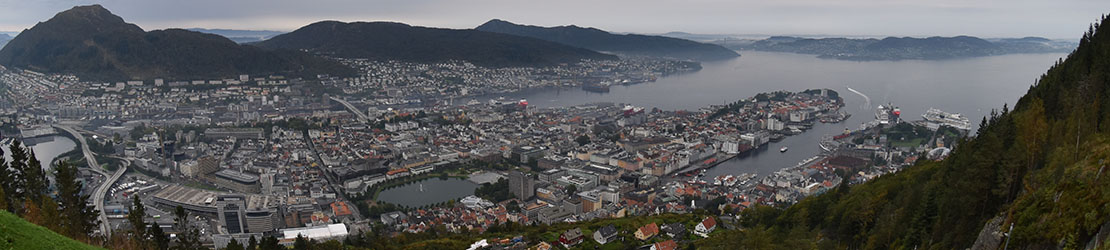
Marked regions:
[377,178,478,208]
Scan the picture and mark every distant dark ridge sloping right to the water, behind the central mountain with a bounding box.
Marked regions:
[475,19,739,61]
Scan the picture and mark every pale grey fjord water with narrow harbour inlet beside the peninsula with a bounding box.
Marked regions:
[475,51,1066,178]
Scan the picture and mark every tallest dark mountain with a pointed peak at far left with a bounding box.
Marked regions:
[0,6,354,81]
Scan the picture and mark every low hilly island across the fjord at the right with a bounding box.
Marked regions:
[714,36,1077,61]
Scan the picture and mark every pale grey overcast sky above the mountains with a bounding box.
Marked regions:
[0,0,1110,39]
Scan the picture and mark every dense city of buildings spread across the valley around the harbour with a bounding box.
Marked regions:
[0,59,967,249]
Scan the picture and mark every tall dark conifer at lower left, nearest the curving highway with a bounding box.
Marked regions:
[54,161,100,239]
